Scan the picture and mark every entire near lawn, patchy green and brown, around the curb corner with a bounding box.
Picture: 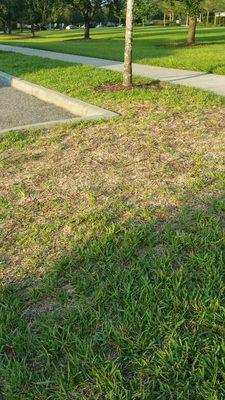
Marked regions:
[0,53,225,400]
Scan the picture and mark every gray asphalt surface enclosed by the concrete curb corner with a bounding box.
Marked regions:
[0,80,75,130]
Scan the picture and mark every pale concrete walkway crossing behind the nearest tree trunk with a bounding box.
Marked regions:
[0,44,225,96]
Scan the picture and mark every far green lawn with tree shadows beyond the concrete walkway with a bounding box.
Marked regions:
[0,27,225,74]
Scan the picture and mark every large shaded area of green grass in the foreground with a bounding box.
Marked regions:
[0,188,225,400]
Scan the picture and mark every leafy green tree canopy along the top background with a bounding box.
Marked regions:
[0,0,225,35]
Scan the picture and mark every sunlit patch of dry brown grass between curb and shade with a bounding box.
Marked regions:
[0,102,225,279]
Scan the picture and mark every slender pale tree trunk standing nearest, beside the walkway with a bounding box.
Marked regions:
[123,0,134,86]
